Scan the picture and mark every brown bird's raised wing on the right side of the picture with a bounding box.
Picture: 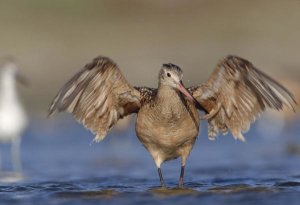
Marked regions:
[189,56,296,141]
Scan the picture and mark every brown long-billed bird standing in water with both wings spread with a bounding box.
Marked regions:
[49,56,295,187]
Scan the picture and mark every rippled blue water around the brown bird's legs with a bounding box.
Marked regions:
[0,116,300,205]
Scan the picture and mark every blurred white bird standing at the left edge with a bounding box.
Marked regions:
[0,61,27,172]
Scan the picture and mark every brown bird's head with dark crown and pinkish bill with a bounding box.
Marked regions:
[159,63,195,101]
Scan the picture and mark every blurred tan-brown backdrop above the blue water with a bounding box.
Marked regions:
[0,0,300,116]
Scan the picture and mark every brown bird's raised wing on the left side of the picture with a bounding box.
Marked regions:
[49,56,141,141]
